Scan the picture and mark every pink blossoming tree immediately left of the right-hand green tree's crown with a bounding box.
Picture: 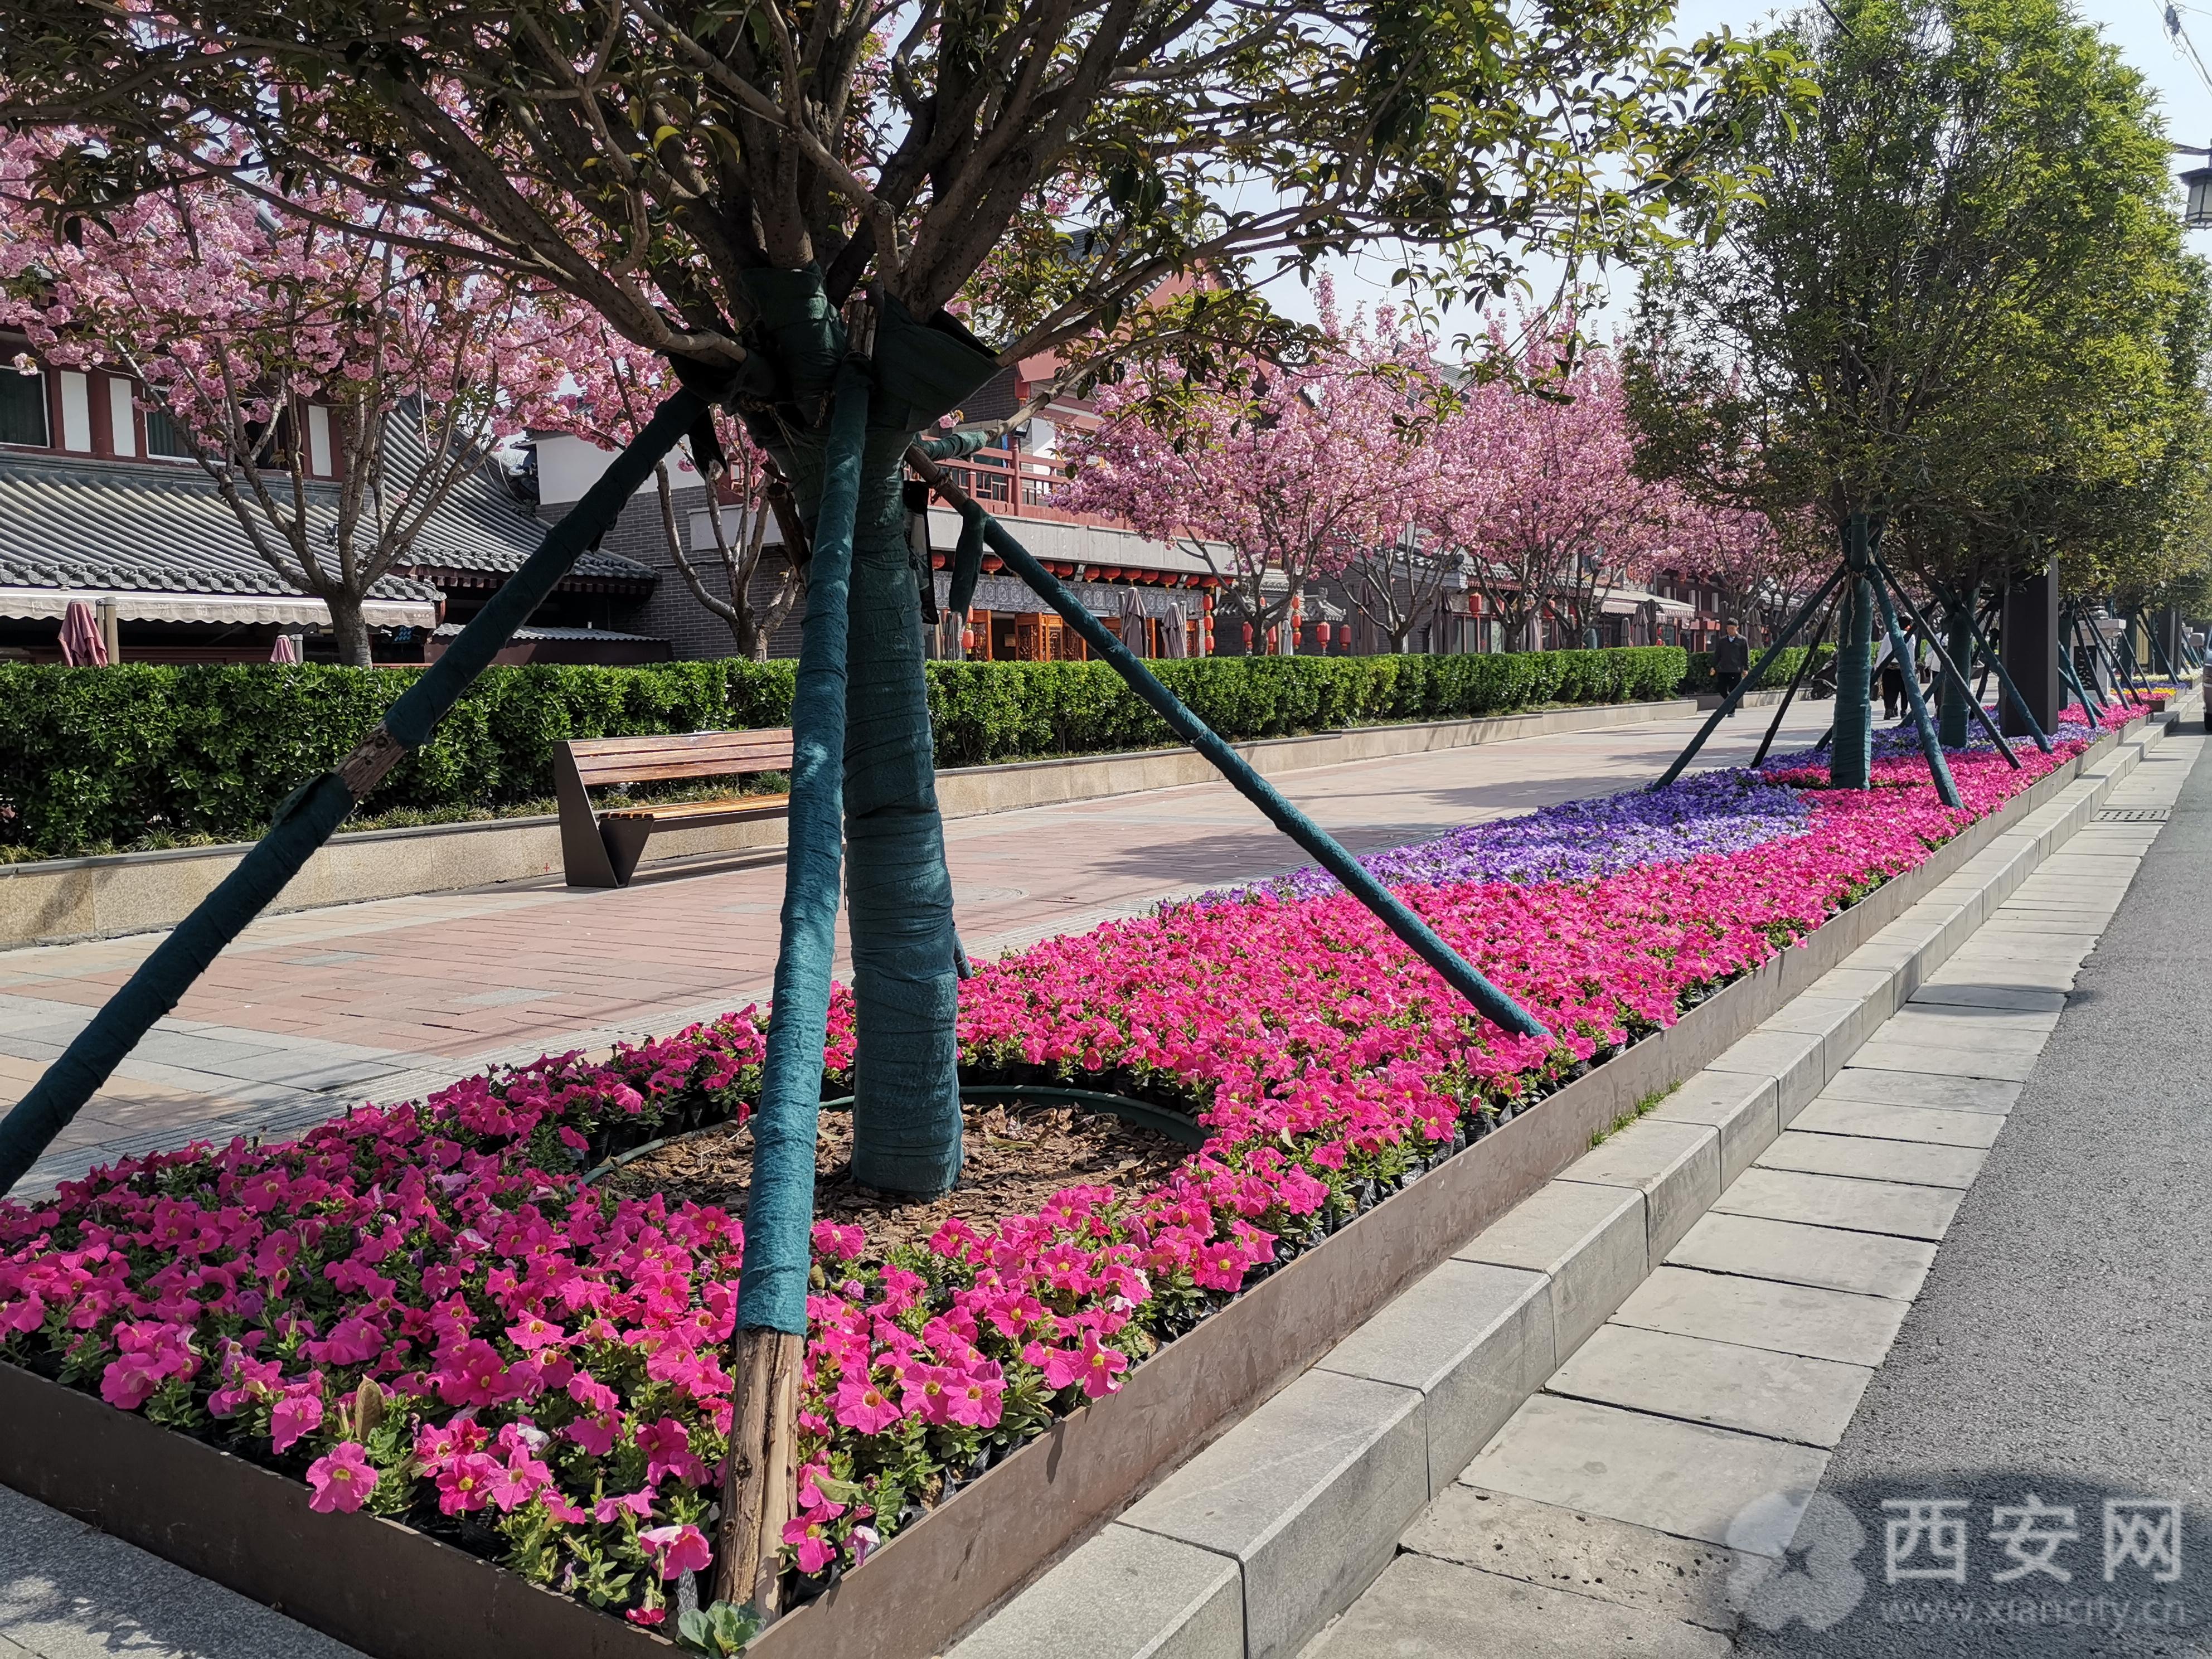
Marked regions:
[1438,325,1661,646]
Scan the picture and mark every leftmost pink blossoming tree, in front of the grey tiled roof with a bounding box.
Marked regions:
[0,135,582,668]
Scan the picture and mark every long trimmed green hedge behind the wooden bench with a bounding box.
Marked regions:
[0,646,1686,858]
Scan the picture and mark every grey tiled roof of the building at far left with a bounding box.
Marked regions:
[0,435,653,599]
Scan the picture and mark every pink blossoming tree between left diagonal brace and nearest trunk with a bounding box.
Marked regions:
[542,318,805,661]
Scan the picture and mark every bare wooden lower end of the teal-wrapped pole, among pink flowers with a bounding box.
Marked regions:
[715,1330,807,1619]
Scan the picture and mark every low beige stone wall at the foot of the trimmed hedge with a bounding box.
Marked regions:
[0,699,1696,949]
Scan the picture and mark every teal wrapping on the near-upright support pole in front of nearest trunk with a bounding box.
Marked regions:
[736,367,867,1336]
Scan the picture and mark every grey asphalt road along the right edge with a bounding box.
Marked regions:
[1739,745,2212,1659]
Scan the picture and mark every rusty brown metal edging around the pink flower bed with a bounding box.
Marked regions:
[0,721,2139,1659]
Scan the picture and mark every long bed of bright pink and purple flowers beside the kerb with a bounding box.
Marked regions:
[0,712,2121,1624]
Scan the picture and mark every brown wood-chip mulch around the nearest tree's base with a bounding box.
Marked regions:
[601,1102,1190,1250]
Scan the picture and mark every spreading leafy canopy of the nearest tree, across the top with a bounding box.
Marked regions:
[0,0,1803,367]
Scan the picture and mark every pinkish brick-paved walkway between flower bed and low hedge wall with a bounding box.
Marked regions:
[0,704,1832,1192]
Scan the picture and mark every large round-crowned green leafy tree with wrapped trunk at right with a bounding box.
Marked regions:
[1630,0,2194,783]
